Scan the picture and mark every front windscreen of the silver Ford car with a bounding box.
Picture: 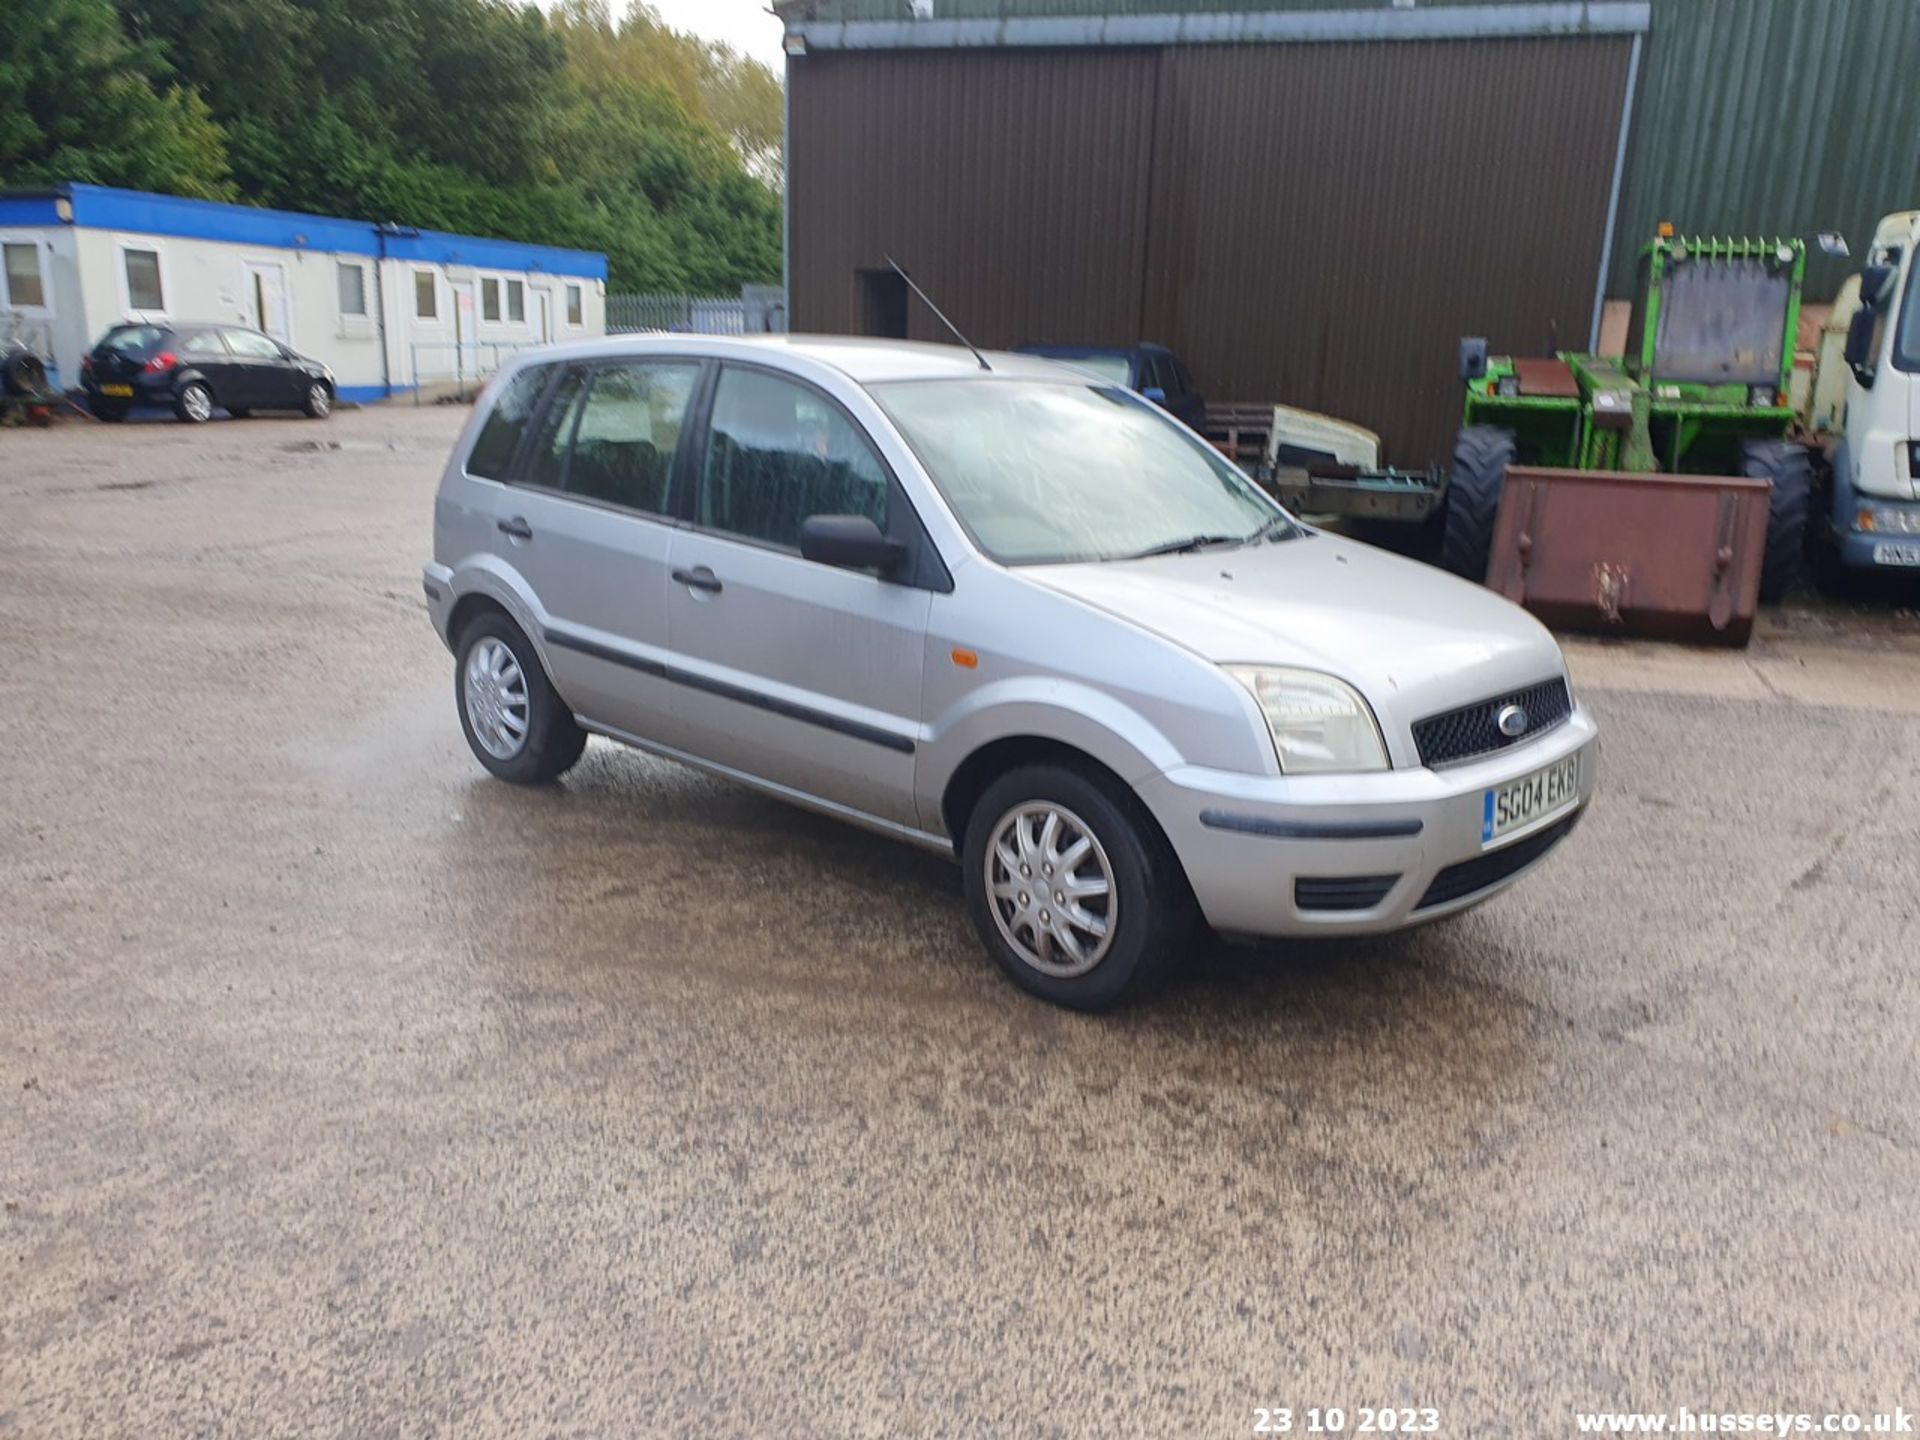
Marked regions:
[872,378,1294,564]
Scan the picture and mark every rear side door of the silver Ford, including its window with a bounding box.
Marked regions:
[495,355,703,745]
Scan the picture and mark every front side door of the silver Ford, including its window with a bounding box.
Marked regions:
[668,365,931,828]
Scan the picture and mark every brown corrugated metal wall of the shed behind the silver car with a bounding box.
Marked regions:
[787,36,1630,465]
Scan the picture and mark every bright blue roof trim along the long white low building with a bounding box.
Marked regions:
[43,184,607,280]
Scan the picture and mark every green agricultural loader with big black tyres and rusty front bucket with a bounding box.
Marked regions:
[1440,225,1843,618]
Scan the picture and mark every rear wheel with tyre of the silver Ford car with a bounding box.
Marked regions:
[453,611,588,785]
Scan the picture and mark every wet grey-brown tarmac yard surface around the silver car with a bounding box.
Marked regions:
[0,407,1920,1440]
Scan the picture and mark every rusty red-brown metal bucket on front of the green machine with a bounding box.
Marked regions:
[1486,465,1772,645]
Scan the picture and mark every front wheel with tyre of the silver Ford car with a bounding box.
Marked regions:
[962,764,1196,1010]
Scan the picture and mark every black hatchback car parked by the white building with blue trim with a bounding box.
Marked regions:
[81,324,334,424]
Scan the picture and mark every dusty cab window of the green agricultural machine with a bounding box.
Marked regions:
[1653,259,1791,386]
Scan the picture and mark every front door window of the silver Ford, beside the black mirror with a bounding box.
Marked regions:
[699,367,887,549]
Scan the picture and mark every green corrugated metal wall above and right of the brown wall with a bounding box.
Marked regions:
[781,0,1920,300]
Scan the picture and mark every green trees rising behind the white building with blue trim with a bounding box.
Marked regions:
[0,0,781,292]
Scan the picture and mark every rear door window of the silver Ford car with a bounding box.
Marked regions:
[566,361,701,515]
